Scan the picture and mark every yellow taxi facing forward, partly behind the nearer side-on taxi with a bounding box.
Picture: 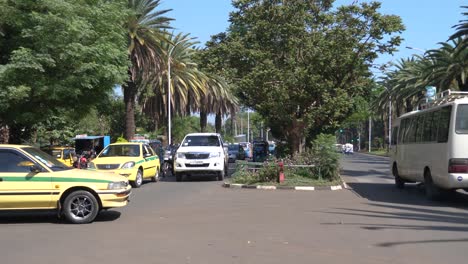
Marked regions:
[88,142,161,188]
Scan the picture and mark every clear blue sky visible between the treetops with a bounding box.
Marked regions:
[160,0,468,73]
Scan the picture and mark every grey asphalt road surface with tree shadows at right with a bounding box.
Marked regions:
[0,154,468,264]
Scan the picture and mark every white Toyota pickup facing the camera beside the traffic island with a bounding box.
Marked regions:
[174,133,228,181]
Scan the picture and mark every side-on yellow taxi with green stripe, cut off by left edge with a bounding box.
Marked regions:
[0,144,131,224]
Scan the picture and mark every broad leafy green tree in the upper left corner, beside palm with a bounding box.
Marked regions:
[0,0,128,143]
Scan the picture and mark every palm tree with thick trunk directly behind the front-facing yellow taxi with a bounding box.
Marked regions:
[122,0,172,139]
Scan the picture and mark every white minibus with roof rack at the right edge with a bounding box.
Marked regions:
[390,90,468,199]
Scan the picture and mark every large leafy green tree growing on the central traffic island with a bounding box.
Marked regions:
[218,0,404,152]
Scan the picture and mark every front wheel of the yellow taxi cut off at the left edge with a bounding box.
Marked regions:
[62,191,100,224]
